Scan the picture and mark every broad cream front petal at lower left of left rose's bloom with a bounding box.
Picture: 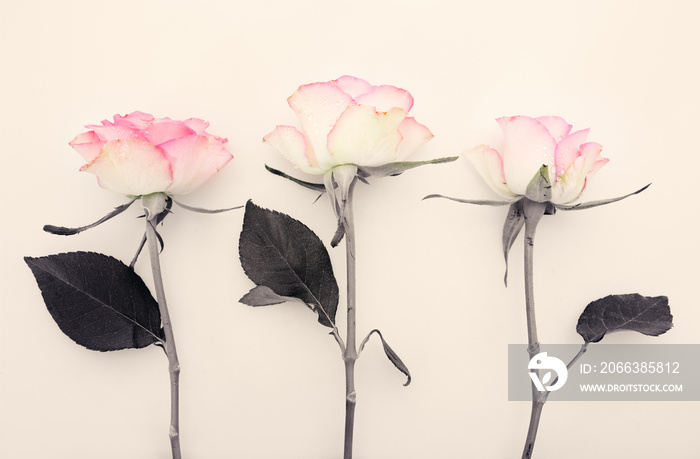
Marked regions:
[81,139,172,196]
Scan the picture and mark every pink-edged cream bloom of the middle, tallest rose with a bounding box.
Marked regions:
[263,76,433,174]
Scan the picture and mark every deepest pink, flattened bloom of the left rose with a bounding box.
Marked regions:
[70,112,233,196]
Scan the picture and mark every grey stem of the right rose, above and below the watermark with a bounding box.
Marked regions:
[522,198,547,459]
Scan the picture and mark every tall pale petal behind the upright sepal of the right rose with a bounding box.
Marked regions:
[496,116,557,196]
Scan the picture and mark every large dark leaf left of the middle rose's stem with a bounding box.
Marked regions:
[238,201,338,327]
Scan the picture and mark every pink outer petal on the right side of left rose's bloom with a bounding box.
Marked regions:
[159,135,233,195]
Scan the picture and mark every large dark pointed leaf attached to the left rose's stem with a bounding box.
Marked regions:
[24,252,165,351]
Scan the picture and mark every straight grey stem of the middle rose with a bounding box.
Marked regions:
[343,180,357,459]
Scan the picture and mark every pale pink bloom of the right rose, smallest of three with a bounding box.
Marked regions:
[465,116,608,204]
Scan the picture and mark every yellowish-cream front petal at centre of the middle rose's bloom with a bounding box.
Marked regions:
[326,105,407,170]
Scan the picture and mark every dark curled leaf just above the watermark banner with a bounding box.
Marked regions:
[576,293,673,343]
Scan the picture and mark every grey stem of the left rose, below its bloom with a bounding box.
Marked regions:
[146,215,182,459]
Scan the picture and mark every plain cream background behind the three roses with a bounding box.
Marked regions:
[0,0,700,459]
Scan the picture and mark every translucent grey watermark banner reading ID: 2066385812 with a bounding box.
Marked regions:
[508,343,700,402]
